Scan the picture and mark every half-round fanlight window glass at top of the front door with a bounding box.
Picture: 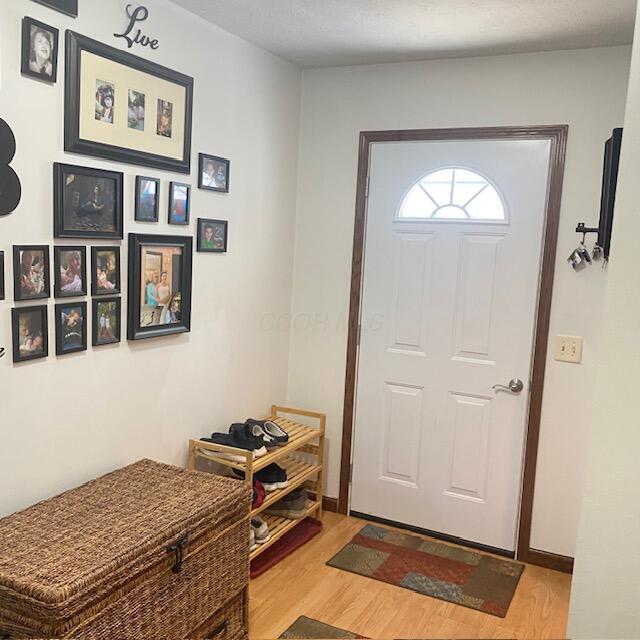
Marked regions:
[398,168,507,222]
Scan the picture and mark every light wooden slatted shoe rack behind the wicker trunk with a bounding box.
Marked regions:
[188,405,326,559]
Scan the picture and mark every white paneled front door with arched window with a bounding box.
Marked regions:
[351,140,551,551]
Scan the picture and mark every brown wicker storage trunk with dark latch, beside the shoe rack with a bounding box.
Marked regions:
[0,460,250,640]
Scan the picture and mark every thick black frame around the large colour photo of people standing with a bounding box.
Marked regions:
[127,233,193,340]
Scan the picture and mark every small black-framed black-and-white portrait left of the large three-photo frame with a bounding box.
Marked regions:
[20,17,59,84]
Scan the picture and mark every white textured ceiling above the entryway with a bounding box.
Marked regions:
[173,0,636,68]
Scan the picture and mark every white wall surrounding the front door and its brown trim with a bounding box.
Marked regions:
[288,47,630,555]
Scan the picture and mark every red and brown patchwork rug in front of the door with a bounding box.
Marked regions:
[327,525,524,618]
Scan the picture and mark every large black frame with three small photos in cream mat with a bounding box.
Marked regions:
[64,31,193,173]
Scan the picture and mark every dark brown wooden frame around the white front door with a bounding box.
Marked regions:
[338,125,573,572]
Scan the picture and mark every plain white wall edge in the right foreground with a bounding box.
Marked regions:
[567,7,640,639]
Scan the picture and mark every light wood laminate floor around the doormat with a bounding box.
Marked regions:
[249,513,571,640]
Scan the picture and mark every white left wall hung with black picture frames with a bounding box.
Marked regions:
[0,0,300,515]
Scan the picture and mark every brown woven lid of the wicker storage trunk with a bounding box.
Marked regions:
[0,460,251,610]
